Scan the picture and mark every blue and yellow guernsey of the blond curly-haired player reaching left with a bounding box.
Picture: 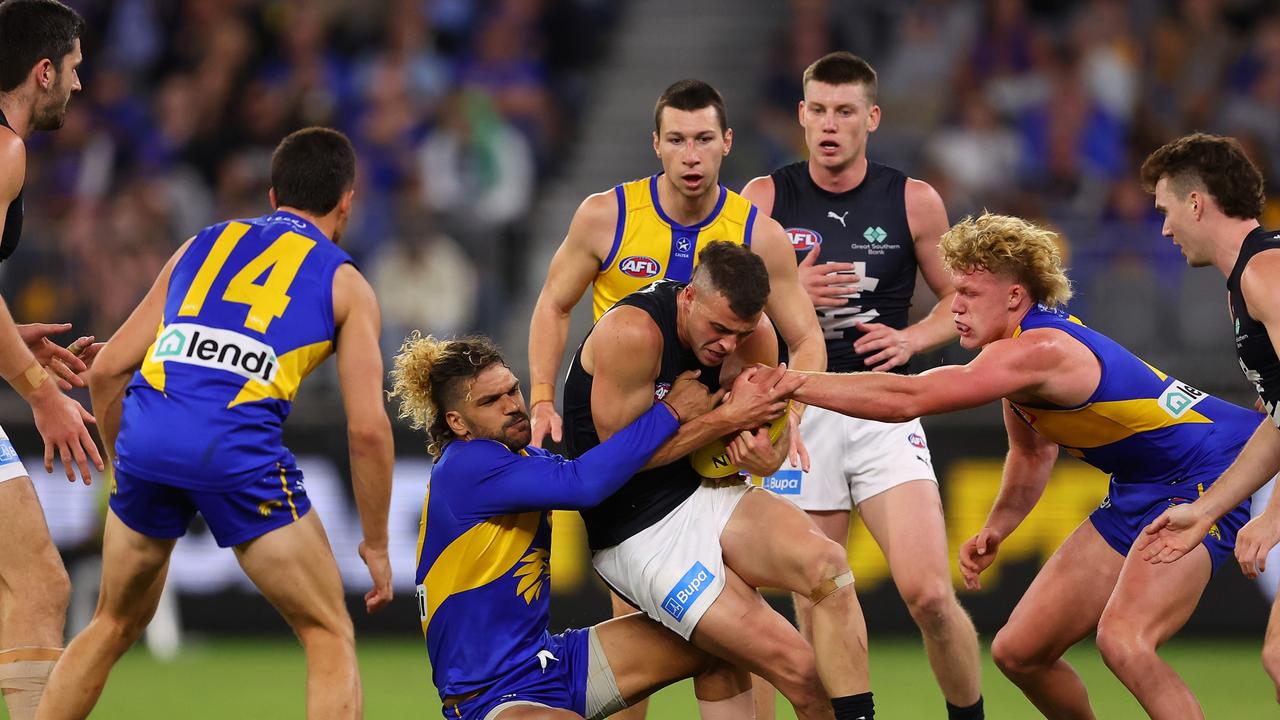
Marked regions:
[1012,305,1262,484]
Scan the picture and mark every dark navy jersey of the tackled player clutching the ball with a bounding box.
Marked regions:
[564,281,721,551]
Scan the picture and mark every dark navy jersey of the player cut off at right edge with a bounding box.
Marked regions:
[1226,227,1280,427]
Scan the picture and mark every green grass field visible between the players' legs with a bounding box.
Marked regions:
[0,638,1277,720]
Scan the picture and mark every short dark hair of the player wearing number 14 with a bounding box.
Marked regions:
[271,127,356,215]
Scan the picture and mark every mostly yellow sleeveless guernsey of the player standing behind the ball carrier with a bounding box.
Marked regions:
[591,173,756,320]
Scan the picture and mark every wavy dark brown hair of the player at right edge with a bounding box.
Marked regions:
[1140,132,1265,220]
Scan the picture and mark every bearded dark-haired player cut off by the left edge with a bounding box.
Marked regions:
[0,0,102,720]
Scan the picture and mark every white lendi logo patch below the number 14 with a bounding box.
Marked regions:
[151,323,280,384]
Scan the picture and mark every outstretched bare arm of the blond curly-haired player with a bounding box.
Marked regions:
[795,333,1061,423]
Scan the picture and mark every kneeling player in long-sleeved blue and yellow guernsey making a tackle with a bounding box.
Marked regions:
[392,333,782,720]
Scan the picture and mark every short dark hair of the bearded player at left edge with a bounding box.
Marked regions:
[0,0,84,92]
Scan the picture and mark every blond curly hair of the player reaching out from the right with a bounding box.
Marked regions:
[938,213,1071,307]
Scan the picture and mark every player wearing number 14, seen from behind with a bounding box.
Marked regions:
[38,128,393,719]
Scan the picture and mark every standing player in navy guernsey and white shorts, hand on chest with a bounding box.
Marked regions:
[742,53,982,719]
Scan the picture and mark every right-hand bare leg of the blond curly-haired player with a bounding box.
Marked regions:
[1098,544,1212,720]
